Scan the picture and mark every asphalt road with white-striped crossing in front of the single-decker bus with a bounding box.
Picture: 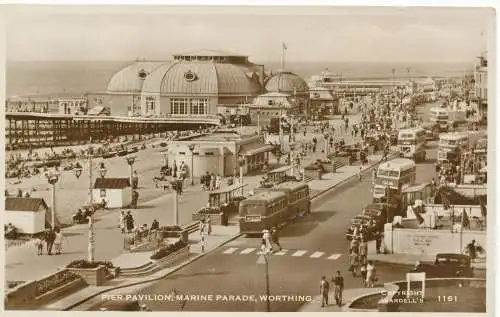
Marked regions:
[92,139,436,312]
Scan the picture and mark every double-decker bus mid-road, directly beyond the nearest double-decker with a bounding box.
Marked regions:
[398,128,427,162]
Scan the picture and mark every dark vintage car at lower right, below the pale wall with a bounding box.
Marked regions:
[411,253,473,278]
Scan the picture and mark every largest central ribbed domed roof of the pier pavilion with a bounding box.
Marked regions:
[158,61,260,95]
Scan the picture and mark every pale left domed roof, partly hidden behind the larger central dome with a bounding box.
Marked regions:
[107,61,165,92]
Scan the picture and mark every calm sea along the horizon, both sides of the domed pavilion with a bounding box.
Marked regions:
[6,61,473,98]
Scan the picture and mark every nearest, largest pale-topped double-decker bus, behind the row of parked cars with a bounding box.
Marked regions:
[373,158,417,202]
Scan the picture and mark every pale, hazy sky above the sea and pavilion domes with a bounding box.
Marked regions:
[4,6,496,62]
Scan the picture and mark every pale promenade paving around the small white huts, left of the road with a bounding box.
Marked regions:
[5,123,348,281]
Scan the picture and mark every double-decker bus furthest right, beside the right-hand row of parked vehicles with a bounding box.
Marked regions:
[437,132,469,165]
